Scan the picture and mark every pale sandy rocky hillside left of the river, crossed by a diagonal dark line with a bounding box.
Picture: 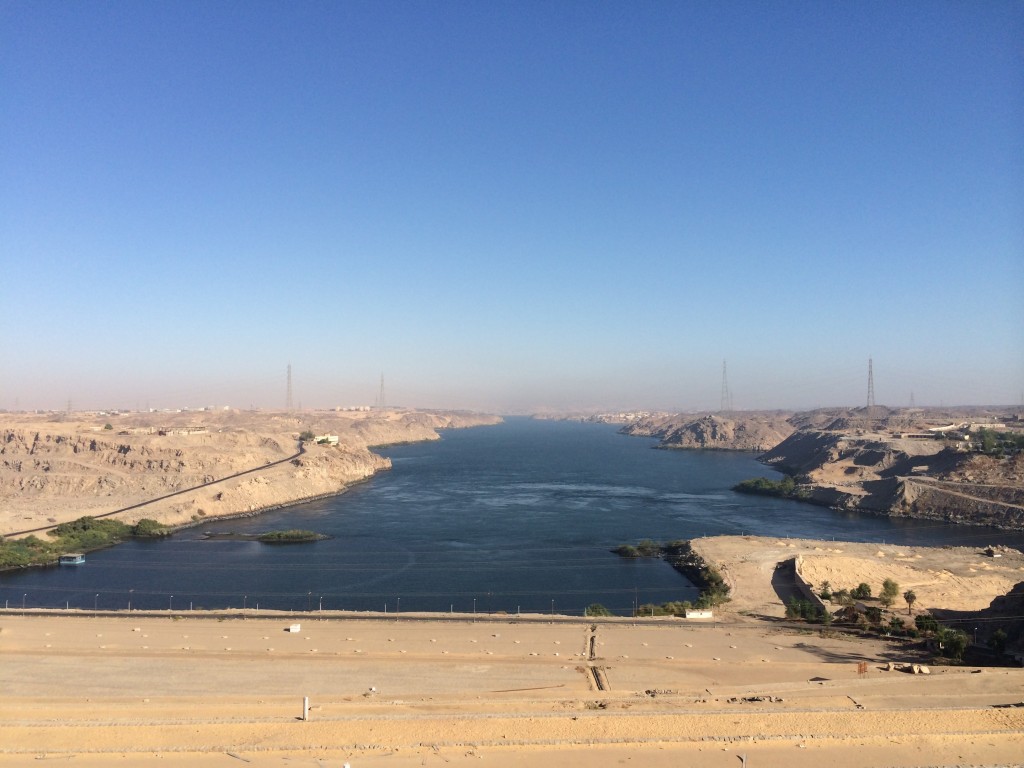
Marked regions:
[0,411,500,535]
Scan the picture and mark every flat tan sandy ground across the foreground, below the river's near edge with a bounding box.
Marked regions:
[0,611,1024,768]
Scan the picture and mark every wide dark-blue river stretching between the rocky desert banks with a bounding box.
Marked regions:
[0,419,1024,614]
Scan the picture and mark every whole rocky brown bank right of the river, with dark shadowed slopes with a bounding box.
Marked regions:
[614,406,1024,530]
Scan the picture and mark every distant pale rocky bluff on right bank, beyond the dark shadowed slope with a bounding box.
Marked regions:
[622,413,794,451]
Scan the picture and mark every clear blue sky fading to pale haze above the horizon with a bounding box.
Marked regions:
[0,0,1024,412]
